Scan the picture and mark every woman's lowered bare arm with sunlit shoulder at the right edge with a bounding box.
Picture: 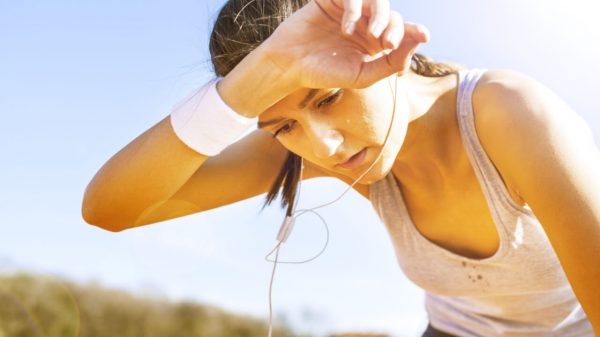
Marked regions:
[474,71,600,323]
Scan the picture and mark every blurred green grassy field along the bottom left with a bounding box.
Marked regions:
[0,272,388,337]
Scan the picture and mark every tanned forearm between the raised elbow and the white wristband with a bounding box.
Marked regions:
[82,116,208,231]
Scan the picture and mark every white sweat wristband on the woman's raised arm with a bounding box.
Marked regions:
[171,77,258,156]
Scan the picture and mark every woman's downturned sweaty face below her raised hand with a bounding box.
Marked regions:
[259,75,409,184]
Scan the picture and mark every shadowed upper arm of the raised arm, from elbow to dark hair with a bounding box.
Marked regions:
[135,130,324,227]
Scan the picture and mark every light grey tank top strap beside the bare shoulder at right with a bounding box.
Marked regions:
[456,69,523,212]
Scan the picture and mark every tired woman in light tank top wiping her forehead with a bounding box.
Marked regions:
[83,0,600,336]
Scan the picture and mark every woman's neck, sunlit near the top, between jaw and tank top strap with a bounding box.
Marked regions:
[392,71,457,181]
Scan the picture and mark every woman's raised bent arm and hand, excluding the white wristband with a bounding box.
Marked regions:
[82,0,428,231]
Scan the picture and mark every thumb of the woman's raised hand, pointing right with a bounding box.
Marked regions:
[355,24,426,88]
